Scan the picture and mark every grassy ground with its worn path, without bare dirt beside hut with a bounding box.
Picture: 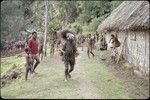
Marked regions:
[1,47,149,99]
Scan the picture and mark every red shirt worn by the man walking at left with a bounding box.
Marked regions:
[28,37,39,54]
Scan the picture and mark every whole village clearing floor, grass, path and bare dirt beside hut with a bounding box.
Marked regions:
[1,48,149,99]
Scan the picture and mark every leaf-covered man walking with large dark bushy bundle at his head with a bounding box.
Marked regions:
[61,30,78,81]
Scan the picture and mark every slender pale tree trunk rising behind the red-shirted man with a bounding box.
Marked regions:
[44,0,48,56]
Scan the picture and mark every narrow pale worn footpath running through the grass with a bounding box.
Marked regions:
[70,49,100,99]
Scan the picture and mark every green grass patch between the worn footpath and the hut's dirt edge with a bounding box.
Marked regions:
[81,58,130,99]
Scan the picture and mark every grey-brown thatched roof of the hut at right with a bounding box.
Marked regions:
[97,1,150,31]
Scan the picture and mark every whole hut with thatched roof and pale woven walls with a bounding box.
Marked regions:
[97,1,150,73]
